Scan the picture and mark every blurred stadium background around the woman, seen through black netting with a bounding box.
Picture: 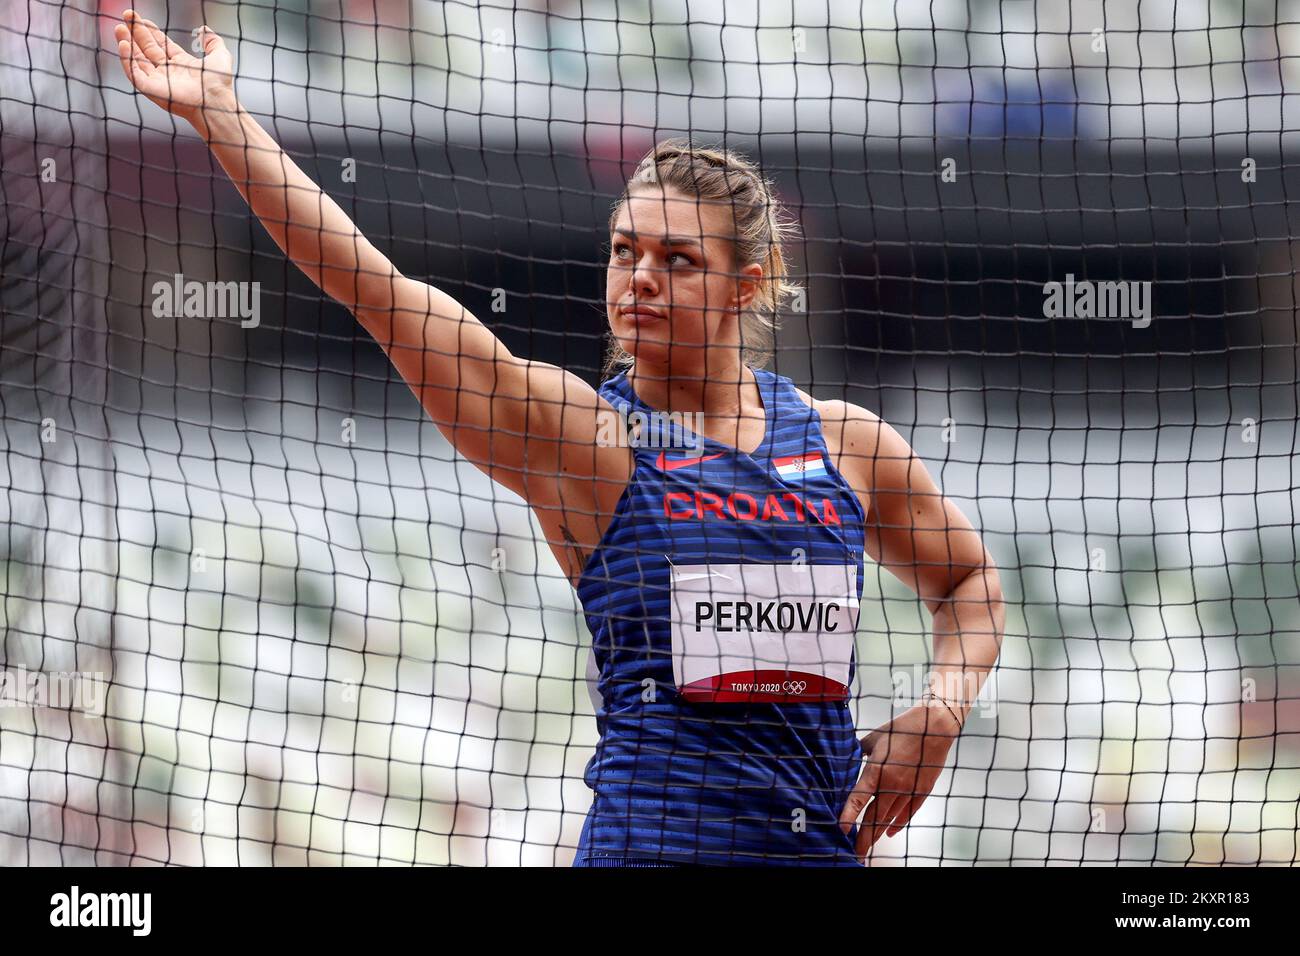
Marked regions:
[0,0,1300,865]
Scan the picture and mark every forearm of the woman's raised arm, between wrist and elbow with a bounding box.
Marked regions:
[187,95,400,313]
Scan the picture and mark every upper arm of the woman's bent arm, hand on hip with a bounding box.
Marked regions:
[836,403,992,611]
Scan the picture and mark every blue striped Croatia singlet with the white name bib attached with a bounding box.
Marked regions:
[575,369,866,866]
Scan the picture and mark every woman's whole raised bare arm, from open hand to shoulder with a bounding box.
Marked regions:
[116,10,631,506]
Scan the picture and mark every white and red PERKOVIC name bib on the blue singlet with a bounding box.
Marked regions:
[671,564,858,704]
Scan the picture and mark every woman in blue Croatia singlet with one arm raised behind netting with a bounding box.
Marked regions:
[116,10,1004,866]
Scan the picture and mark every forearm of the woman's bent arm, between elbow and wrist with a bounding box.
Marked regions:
[931,564,1006,728]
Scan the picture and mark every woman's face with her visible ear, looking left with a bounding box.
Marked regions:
[605,186,763,369]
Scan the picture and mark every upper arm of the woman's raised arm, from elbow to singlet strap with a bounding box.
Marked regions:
[358,276,631,505]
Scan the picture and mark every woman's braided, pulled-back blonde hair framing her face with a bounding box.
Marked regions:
[605,139,800,376]
